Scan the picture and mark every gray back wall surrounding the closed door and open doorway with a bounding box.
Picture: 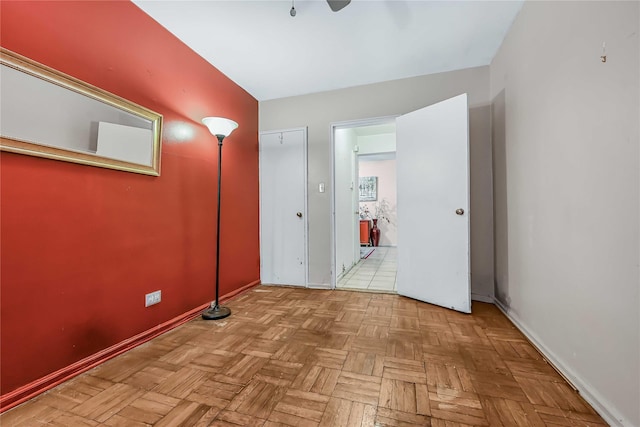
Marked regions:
[259,67,493,296]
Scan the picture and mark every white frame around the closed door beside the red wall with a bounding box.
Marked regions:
[258,126,309,288]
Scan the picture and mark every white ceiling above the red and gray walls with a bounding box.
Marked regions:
[133,0,522,101]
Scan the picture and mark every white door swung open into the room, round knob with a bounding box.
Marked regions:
[396,94,471,313]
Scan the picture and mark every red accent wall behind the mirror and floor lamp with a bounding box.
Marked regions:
[0,1,260,402]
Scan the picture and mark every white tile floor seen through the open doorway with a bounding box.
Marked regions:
[336,246,398,293]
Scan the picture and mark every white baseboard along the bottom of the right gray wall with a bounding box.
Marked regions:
[493,298,633,427]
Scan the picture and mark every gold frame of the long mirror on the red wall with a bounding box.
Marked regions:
[0,47,162,176]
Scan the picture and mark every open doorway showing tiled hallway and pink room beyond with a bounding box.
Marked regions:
[332,117,397,293]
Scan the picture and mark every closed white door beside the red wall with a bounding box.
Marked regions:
[260,129,307,286]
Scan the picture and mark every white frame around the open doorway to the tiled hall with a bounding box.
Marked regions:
[329,114,400,289]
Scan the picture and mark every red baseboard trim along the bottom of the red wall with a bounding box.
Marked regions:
[0,280,260,414]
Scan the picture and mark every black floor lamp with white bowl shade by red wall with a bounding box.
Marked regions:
[202,117,238,320]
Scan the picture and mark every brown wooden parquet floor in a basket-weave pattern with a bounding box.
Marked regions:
[0,286,606,427]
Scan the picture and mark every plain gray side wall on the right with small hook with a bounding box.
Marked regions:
[491,2,640,426]
